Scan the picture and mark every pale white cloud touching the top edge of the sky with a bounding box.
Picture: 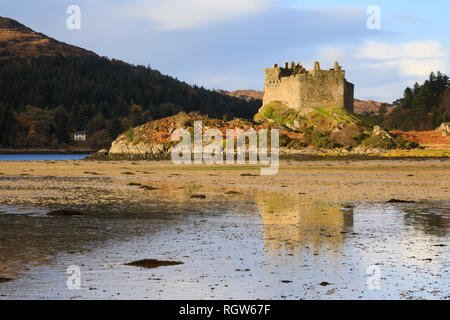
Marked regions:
[121,0,269,30]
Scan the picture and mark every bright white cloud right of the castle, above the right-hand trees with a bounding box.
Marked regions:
[355,41,449,76]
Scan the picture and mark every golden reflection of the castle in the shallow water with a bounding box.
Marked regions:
[257,195,353,255]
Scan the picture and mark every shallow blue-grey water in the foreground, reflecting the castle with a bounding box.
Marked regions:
[0,199,450,299]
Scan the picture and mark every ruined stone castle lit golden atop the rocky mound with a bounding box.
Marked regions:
[263,62,354,112]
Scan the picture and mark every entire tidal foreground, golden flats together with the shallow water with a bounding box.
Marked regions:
[0,160,450,299]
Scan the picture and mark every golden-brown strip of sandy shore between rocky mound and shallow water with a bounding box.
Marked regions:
[0,159,450,212]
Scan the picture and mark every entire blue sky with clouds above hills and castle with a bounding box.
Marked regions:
[0,0,450,102]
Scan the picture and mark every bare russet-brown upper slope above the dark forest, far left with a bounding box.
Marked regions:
[0,17,96,57]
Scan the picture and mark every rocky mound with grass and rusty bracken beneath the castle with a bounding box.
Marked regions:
[90,105,418,160]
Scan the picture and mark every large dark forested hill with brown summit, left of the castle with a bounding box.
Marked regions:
[0,18,260,149]
